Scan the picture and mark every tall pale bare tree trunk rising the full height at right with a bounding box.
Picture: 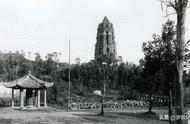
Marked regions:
[175,0,186,124]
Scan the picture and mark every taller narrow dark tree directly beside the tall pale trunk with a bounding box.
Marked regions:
[162,20,176,124]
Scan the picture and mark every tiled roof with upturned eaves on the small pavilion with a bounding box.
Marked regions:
[3,73,54,89]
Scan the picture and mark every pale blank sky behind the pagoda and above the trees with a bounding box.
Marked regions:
[0,0,190,64]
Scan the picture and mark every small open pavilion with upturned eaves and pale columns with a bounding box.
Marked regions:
[3,72,54,109]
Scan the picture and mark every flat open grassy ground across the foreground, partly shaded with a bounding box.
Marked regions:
[0,107,189,124]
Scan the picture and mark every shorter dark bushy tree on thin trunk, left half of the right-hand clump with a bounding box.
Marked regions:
[141,34,162,112]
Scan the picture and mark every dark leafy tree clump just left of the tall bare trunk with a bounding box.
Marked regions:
[142,20,177,111]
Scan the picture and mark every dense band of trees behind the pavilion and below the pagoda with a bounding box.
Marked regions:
[0,50,144,105]
